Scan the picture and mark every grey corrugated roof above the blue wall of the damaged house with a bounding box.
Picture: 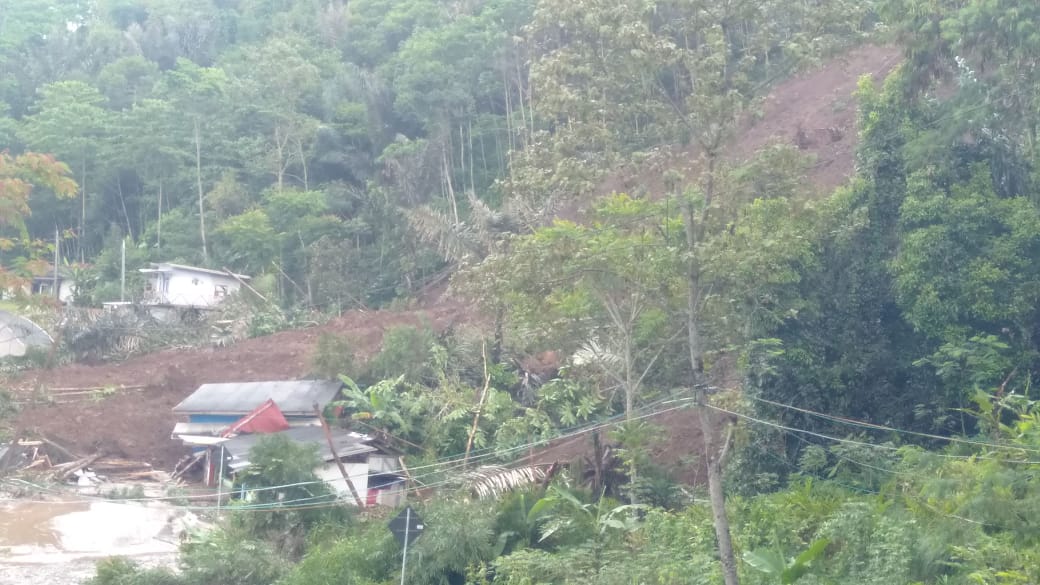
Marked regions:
[174,380,343,416]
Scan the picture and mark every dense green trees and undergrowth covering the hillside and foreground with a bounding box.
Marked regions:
[6,0,1040,585]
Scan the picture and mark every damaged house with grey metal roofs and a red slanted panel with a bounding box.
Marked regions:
[173,380,405,506]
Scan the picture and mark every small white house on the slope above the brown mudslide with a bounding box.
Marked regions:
[140,262,250,309]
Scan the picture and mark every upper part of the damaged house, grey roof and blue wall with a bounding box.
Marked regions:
[174,380,343,436]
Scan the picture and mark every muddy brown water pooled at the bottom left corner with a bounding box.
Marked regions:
[0,501,184,585]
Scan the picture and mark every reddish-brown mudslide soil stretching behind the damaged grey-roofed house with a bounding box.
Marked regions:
[14,303,461,470]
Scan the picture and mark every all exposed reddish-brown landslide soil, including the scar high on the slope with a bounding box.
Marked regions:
[6,46,900,474]
